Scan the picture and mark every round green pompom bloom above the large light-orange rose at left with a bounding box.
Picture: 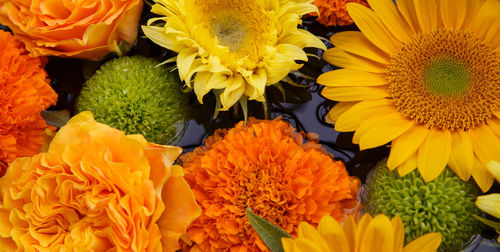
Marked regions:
[76,56,186,144]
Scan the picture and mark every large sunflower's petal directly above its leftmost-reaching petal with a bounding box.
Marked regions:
[323,47,385,73]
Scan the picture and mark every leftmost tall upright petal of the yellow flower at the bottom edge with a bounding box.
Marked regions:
[318,215,351,252]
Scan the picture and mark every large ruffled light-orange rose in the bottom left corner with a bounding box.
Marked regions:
[0,112,200,251]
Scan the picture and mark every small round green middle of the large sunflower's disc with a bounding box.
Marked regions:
[424,59,470,96]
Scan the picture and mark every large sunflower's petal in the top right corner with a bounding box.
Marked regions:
[470,0,500,40]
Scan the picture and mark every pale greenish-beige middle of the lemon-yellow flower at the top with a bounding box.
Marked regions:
[211,16,247,51]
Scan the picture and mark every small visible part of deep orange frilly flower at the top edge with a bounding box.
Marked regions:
[312,0,368,26]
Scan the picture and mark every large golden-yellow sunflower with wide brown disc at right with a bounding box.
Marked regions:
[317,0,500,191]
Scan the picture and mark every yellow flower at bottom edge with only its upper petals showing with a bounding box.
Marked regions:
[282,214,441,252]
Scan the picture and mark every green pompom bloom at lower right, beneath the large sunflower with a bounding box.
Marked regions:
[365,161,480,251]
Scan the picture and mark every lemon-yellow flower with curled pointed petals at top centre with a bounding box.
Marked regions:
[142,0,326,110]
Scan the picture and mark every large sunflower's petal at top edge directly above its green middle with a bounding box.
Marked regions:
[441,0,468,29]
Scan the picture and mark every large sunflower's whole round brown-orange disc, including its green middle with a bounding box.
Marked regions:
[386,29,500,130]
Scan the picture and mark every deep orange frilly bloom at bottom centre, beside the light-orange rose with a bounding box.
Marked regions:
[181,118,360,251]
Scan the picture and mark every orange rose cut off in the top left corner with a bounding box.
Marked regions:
[0,0,143,60]
